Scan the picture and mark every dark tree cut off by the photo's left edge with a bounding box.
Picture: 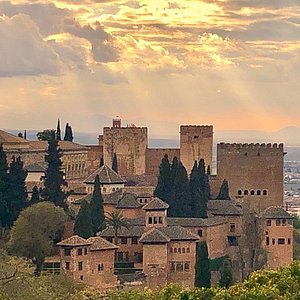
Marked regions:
[0,144,11,228]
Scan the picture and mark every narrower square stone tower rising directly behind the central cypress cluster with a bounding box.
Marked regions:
[180,125,213,173]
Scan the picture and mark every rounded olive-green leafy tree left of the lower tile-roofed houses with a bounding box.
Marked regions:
[9,202,66,275]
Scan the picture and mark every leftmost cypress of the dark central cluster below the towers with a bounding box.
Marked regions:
[154,154,172,203]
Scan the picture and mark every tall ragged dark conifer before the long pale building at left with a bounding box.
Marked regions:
[41,132,67,209]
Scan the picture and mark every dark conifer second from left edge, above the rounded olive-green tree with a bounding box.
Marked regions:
[8,156,27,225]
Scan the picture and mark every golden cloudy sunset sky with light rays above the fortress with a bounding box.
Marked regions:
[0,0,300,136]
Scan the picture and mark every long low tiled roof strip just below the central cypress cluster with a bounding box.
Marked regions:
[167,217,226,227]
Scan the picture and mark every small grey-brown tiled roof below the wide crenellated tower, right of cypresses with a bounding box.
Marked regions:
[207,200,242,216]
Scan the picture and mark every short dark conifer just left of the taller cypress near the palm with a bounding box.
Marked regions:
[74,200,93,239]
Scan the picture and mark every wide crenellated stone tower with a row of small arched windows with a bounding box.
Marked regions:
[217,143,284,212]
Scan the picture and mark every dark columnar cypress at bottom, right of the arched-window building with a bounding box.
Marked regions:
[195,242,211,288]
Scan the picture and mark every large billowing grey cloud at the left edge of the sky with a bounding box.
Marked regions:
[0,15,62,77]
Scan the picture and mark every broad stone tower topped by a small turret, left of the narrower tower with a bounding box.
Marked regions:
[103,118,148,176]
